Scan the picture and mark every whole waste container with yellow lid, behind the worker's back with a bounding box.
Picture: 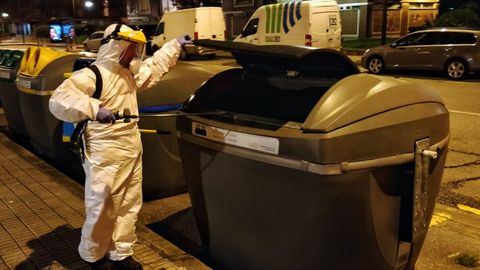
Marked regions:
[16,47,79,160]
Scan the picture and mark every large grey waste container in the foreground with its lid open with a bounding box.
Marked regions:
[177,42,449,270]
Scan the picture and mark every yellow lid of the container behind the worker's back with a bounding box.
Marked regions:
[18,47,72,77]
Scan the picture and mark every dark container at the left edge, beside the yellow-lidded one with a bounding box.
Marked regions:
[0,50,27,139]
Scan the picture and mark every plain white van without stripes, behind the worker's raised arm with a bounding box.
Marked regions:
[152,7,226,59]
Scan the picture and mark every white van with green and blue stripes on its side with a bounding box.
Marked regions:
[234,0,342,50]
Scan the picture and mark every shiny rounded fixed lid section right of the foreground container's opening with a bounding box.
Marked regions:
[302,74,443,132]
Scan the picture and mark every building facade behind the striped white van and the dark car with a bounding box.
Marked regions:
[218,0,440,39]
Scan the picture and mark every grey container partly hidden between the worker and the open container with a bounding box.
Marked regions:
[138,62,231,200]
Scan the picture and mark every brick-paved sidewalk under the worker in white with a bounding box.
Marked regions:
[0,113,209,270]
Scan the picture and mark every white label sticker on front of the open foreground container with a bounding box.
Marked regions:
[192,122,280,155]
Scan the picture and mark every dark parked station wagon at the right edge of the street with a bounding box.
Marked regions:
[362,28,480,80]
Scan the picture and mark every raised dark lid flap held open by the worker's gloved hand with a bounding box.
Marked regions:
[194,40,359,78]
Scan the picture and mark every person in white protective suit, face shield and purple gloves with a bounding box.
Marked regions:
[49,24,191,269]
